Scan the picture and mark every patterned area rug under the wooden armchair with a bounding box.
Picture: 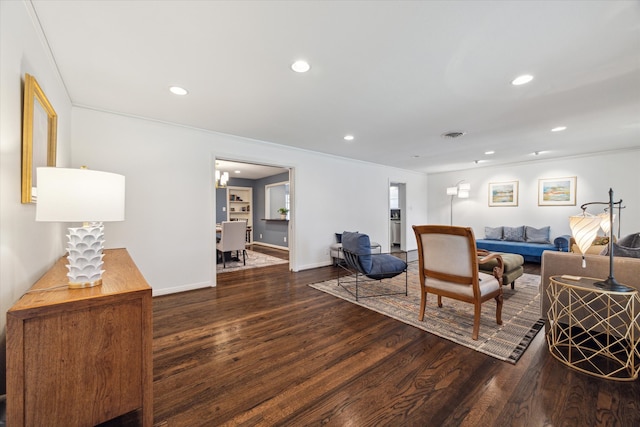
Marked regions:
[309,262,544,364]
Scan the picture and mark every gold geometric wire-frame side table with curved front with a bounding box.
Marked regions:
[547,276,640,381]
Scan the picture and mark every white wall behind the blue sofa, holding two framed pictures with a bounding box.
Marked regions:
[428,149,640,238]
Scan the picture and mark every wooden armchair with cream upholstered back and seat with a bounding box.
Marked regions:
[413,225,504,340]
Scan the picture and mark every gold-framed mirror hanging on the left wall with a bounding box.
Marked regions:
[22,74,58,203]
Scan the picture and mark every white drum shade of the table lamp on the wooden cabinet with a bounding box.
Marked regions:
[36,167,125,222]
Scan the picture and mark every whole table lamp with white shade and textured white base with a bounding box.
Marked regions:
[36,167,125,288]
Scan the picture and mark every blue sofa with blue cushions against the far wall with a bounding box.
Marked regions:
[476,227,571,264]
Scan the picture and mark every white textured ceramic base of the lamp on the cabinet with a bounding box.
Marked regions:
[67,222,104,288]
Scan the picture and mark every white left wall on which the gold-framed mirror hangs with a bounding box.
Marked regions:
[0,1,71,392]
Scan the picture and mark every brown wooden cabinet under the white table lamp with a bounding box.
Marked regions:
[7,249,153,427]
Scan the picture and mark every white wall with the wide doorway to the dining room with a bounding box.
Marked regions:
[72,107,427,295]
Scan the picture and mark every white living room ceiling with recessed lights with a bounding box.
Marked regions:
[32,0,640,172]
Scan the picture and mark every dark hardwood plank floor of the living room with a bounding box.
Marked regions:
[148,251,640,426]
